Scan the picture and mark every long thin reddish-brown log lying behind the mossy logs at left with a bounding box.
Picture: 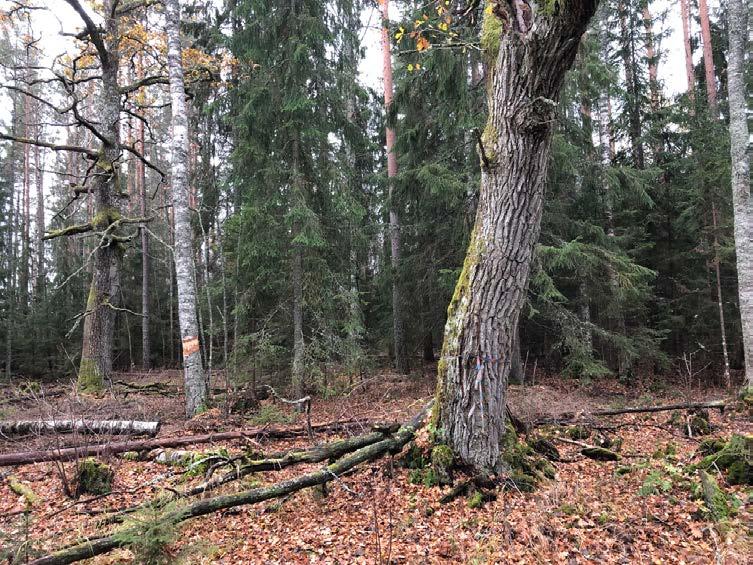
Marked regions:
[0,420,390,467]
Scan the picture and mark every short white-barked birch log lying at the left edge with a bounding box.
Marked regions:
[0,419,161,436]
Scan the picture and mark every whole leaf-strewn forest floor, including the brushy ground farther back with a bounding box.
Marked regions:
[0,371,753,564]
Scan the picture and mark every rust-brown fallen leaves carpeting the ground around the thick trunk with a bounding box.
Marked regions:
[0,377,751,565]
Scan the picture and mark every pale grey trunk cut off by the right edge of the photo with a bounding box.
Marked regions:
[727,0,753,387]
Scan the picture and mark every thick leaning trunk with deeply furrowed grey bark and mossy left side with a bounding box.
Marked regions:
[433,0,597,470]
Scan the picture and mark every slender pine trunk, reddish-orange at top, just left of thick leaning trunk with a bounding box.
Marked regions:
[380,0,409,374]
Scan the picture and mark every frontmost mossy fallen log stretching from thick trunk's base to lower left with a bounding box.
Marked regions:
[31,406,429,565]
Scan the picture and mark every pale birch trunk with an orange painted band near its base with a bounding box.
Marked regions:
[165,0,208,418]
